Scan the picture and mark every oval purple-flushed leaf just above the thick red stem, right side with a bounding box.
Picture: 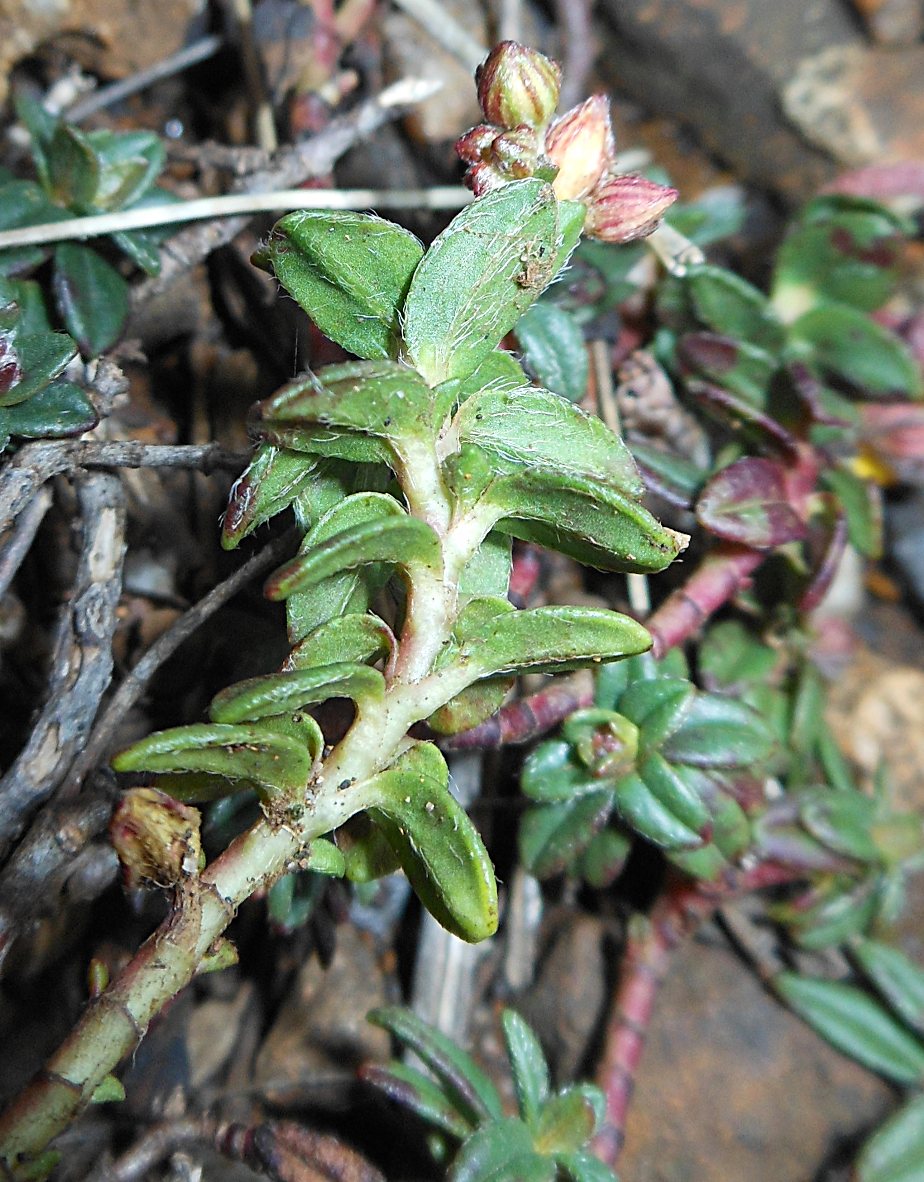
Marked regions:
[696,456,806,550]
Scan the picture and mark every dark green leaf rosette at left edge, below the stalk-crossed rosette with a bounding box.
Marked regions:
[0,279,98,452]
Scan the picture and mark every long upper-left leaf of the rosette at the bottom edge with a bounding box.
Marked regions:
[366,1006,503,1124]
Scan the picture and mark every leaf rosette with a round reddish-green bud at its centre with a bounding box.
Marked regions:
[520,651,774,887]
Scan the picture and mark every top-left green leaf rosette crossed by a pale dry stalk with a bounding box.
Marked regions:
[0,96,173,357]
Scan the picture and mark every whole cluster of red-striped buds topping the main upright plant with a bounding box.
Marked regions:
[456,41,677,242]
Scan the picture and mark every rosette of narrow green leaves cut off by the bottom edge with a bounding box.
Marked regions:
[360,1006,614,1182]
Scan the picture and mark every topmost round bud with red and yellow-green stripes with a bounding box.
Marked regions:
[475,41,561,128]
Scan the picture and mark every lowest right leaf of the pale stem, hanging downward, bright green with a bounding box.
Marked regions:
[363,743,497,943]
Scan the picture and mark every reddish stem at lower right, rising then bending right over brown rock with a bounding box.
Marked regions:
[593,863,803,1167]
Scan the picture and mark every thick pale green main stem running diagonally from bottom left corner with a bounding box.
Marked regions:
[0,450,474,1177]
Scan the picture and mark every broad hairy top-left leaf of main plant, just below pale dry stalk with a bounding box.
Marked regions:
[254,209,423,358]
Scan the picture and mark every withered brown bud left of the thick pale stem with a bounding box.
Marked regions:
[109,788,202,889]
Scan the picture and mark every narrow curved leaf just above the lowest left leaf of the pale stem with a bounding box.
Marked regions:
[209,662,385,723]
